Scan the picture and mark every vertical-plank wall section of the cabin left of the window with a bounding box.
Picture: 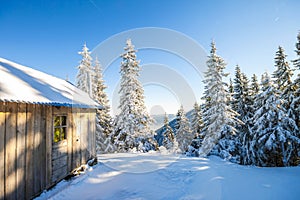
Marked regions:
[0,102,52,199]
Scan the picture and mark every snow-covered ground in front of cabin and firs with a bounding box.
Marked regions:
[36,153,300,200]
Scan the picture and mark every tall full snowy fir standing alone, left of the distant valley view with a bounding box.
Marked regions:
[113,39,157,151]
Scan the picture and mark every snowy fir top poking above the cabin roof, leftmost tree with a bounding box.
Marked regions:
[76,44,93,97]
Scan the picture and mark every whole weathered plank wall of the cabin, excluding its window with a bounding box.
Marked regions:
[0,102,96,199]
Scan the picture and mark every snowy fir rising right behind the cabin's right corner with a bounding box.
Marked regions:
[92,57,115,153]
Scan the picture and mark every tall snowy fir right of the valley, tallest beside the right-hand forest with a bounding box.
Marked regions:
[199,42,239,161]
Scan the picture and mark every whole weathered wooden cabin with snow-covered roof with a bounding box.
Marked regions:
[0,58,99,199]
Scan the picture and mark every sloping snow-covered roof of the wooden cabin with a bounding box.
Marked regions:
[0,58,99,108]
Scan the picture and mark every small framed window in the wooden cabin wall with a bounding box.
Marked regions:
[53,116,67,142]
